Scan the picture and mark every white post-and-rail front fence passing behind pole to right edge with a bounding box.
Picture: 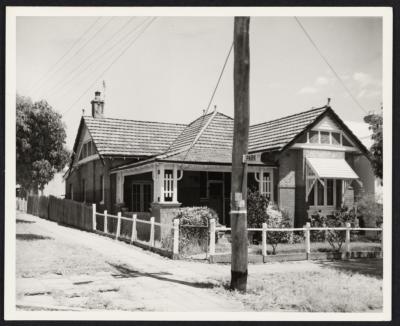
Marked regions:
[209,220,383,257]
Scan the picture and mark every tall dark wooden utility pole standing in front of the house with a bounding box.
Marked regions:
[230,17,250,292]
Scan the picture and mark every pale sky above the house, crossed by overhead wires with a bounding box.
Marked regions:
[16,17,382,149]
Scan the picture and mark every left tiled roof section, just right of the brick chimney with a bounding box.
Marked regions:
[83,116,186,156]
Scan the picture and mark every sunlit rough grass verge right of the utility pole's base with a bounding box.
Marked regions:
[220,269,382,312]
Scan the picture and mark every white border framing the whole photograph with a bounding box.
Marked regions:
[4,7,393,321]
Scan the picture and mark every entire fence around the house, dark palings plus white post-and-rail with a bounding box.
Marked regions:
[16,196,383,258]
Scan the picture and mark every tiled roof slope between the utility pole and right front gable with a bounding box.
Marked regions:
[249,107,327,152]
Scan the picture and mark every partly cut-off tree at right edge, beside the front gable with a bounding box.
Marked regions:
[364,109,383,183]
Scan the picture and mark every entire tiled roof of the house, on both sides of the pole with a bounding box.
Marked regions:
[84,107,327,163]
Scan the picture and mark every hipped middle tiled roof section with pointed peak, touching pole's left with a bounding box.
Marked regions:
[159,112,233,163]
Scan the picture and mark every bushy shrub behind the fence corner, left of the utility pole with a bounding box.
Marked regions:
[162,207,218,255]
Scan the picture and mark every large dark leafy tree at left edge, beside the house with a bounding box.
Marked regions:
[16,95,69,193]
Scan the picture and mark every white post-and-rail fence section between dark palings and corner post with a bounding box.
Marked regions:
[92,204,179,257]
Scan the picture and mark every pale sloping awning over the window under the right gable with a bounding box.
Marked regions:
[306,157,359,180]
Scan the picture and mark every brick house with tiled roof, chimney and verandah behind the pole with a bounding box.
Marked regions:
[65,92,374,226]
